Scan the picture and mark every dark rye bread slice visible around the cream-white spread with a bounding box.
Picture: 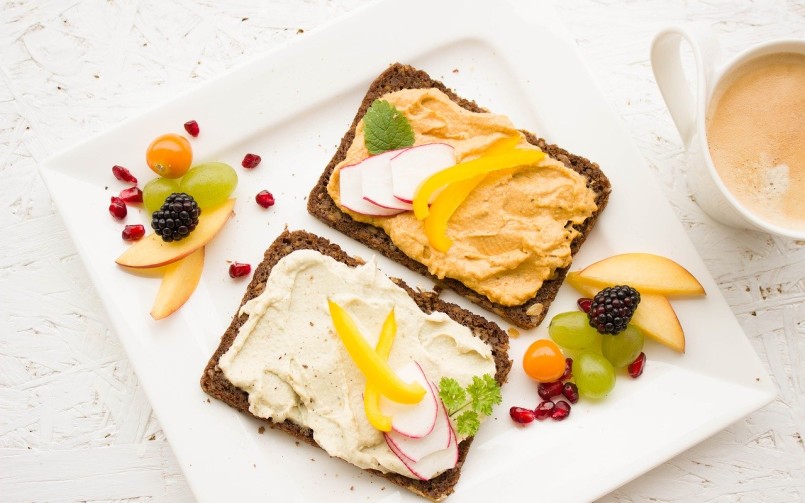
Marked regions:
[201,230,512,501]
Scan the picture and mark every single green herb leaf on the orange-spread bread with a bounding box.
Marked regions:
[363,100,414,155]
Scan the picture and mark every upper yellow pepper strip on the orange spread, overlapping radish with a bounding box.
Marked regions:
[413,149,545,220]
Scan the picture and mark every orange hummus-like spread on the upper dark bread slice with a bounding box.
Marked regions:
[327,89,597,306]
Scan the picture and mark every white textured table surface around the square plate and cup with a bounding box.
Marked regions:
[0,0,805,502]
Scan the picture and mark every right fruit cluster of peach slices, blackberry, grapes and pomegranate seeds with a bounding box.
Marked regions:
[509,253,705,424]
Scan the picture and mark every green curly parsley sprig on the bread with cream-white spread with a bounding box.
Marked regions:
[439,374,503,436]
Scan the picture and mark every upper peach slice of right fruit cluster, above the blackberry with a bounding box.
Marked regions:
[578,253,704,296]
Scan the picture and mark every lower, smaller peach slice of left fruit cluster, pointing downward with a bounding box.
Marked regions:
[151,246,204,320]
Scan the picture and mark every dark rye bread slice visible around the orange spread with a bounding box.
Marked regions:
[307,63,610,328]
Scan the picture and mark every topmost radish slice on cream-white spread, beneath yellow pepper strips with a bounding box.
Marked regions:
[380,361,439,438]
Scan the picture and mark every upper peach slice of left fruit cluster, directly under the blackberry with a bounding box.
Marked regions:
[115,199,235,269]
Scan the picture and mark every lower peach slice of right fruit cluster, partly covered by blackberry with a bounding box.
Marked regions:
[567,272,685,353]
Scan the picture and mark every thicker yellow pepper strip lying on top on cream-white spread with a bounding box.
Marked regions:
[327,300,425,404]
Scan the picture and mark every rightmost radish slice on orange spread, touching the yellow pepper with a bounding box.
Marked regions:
[391,143,456,203]
